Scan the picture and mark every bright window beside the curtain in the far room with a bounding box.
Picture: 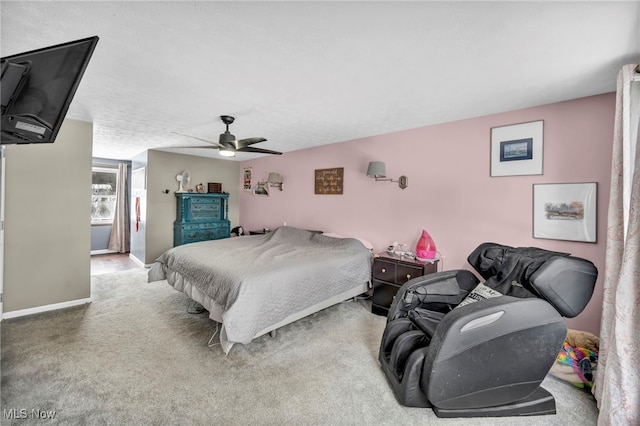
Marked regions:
[91,167,118,225]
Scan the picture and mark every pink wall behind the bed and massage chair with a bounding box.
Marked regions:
[240,93,615,334]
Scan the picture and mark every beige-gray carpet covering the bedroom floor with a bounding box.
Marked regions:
[0,269,597,426]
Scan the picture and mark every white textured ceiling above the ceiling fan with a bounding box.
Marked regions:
[0,1,640,160]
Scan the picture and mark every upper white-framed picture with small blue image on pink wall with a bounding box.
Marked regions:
[491,120,544,177]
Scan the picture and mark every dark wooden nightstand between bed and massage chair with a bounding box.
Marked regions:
[371,253,438,316]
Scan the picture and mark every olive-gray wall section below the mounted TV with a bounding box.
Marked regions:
[4,120,93,313]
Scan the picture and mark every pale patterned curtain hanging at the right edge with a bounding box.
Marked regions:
[593,65,640,425]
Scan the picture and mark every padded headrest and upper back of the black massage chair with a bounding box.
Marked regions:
[467,243,598,318]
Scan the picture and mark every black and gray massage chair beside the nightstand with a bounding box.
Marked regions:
[378,243,598,417]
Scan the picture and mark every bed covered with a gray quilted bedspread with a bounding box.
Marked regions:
[148,227,372,353]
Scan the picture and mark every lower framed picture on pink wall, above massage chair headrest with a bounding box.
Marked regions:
[533,182,598,243]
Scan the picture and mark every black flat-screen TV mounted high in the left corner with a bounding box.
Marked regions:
[0,36,98,145]
